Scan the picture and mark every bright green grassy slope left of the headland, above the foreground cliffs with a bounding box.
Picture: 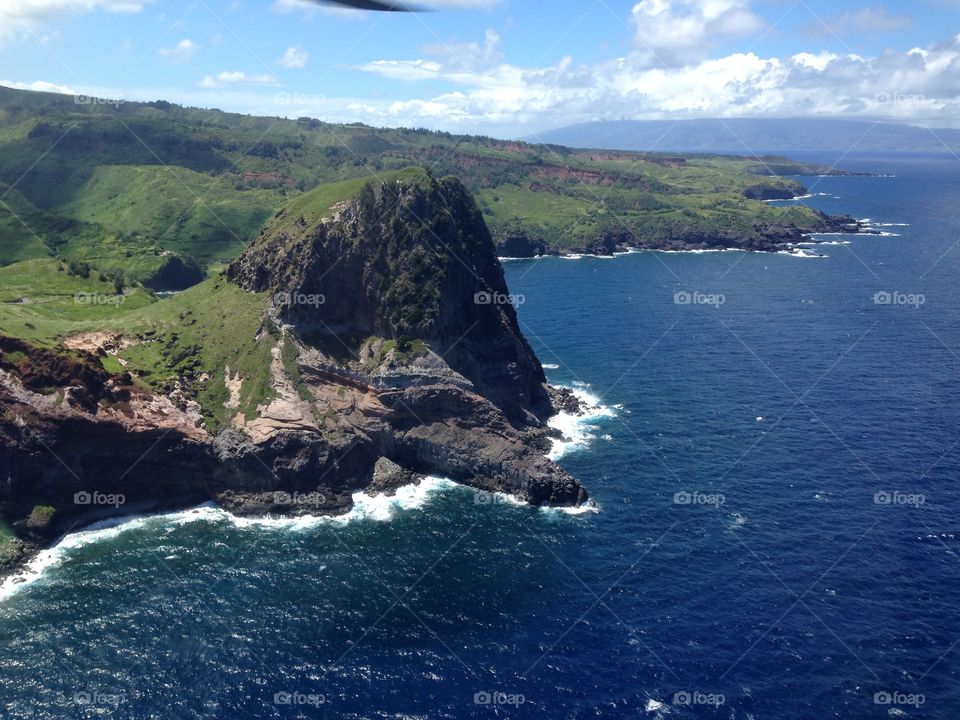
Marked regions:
[0,259,276,427]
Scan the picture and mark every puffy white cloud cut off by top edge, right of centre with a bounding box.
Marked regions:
[630,0,763,66]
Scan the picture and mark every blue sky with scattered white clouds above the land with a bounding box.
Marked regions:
[0,0,960,137]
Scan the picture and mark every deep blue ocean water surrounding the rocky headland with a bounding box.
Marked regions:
[0,149,960,720]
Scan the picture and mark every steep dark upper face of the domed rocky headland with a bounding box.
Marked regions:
[227,174,550,423]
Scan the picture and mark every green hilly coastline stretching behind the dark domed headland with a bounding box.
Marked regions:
[0,88,828,277]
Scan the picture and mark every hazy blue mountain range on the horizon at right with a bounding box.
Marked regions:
[525,118,960,154]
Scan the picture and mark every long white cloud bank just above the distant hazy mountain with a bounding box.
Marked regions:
[354,32,960,133]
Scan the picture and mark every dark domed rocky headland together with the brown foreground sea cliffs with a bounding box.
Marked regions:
[0,174,587,580]
